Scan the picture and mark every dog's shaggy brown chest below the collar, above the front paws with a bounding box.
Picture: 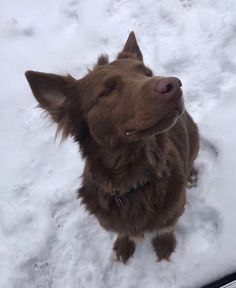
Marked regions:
[97,183,173,235]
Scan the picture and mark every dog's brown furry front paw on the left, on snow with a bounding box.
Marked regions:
[113,236,135,264]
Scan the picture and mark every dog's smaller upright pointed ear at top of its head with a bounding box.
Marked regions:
[117,31,143,62]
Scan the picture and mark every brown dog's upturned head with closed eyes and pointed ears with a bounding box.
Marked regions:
[26,32,184,151]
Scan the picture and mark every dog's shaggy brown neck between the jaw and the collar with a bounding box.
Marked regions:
[83,134,168,195]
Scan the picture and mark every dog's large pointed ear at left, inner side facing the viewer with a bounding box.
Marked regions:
[25,71,75,122]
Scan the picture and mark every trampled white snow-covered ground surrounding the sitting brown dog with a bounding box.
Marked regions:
[0,0,236,288]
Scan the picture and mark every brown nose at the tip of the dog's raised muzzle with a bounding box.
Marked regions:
[155,77,182,94]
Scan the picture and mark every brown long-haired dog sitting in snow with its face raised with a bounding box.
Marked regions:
[26,32,199,262]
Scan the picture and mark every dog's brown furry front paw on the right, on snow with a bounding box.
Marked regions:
[152,233,176,261]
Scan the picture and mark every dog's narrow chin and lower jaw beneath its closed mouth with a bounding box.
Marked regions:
[125,108,184,142]
